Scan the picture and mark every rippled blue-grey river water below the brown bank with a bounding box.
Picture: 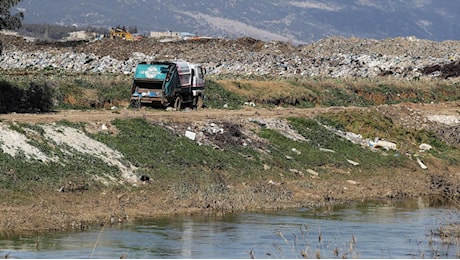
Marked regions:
[0,198,460,259]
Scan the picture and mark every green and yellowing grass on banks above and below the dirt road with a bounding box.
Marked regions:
[0,71,460,203]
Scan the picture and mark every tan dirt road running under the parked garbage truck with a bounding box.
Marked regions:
[0,102,460,126]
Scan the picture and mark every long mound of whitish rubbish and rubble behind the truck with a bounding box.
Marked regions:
[0,35,460,79]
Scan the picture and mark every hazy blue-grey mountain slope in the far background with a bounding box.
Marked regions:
[15,0,460,43]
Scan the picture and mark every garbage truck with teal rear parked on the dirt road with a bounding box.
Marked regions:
[130,60,205,110]
